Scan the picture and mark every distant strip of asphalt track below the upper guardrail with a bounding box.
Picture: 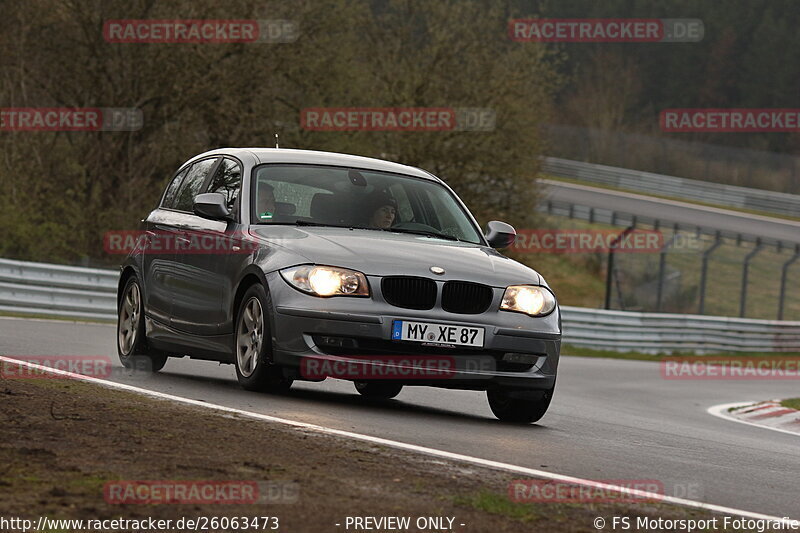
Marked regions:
[542,180,800,243]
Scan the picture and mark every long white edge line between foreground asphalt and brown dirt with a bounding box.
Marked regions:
[0,355,798,528]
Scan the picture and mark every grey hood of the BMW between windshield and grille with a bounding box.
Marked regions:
[251,225,542,287]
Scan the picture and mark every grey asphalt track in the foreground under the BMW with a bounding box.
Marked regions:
[0,318,800,518]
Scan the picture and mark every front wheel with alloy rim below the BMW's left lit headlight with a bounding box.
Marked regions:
[233,284,292,392]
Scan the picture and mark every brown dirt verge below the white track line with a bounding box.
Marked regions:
[0,360,744,533]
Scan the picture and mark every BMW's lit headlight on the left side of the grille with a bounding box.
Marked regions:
[281,265,369,296]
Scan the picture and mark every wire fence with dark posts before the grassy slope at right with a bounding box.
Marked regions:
[540,201,800,320]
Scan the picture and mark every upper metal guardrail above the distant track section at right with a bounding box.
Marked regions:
[542,157,800,217]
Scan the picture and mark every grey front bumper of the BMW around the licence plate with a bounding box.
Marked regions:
[267,273,561,391]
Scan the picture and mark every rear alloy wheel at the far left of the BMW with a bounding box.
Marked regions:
[117,275,167,372]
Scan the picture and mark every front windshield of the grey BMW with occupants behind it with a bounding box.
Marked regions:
[252,165,482,244]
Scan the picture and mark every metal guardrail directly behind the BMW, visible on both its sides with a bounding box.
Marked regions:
[0,259,800,353]
